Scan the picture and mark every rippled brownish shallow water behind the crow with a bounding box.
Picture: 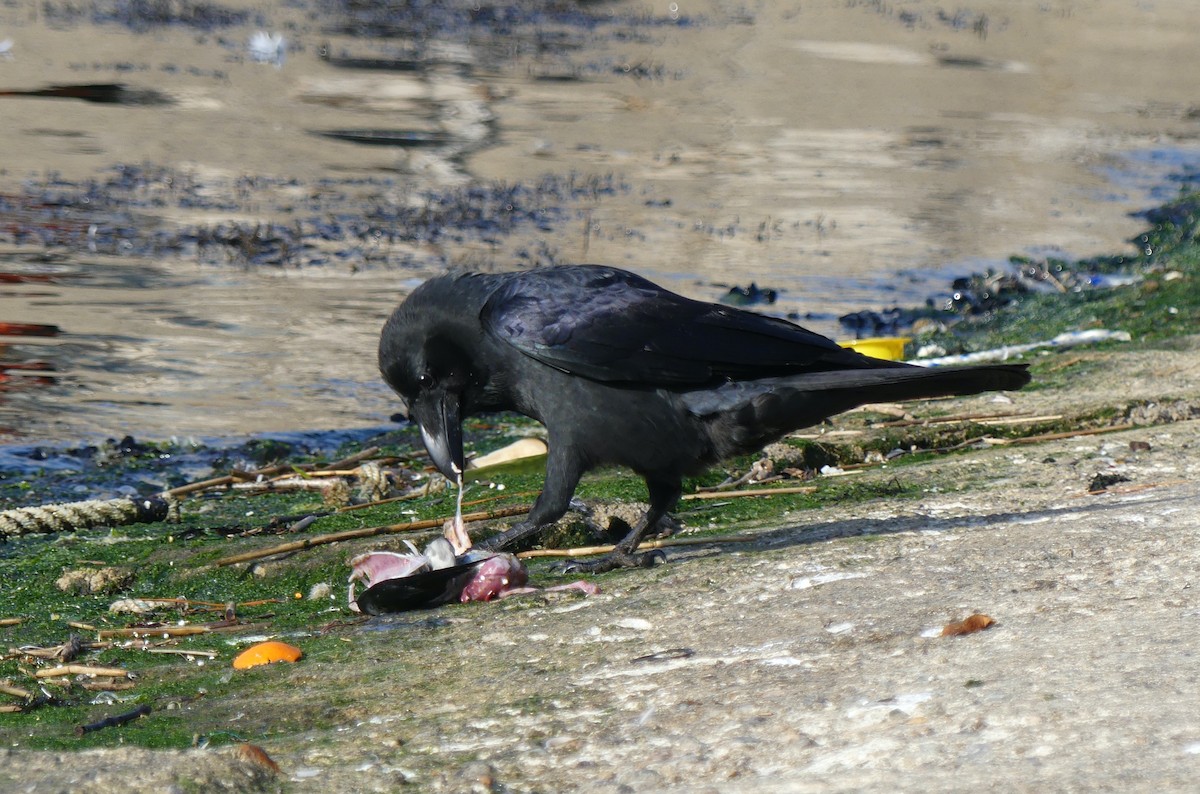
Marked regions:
[0,0,1200,443]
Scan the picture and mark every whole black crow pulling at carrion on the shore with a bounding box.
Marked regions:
[379,265,1030,570]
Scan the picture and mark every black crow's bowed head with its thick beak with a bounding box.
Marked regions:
[379,278,479,480]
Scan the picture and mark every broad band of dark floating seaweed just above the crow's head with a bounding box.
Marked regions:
[0,166,628,267]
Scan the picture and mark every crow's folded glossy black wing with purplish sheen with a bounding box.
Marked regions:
[481,266,894,386]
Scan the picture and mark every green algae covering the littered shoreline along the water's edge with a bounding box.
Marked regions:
[0,191,1200,748]
